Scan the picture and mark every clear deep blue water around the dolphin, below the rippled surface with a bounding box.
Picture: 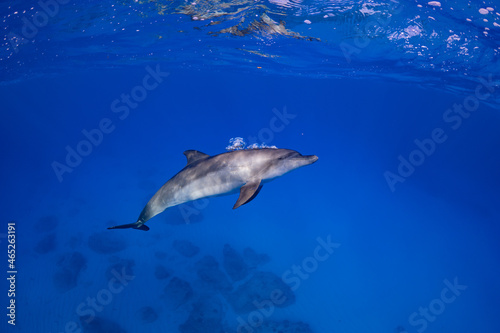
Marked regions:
[0,68,500,333]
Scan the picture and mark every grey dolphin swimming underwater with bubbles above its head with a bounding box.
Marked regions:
[108,148,318,231]
